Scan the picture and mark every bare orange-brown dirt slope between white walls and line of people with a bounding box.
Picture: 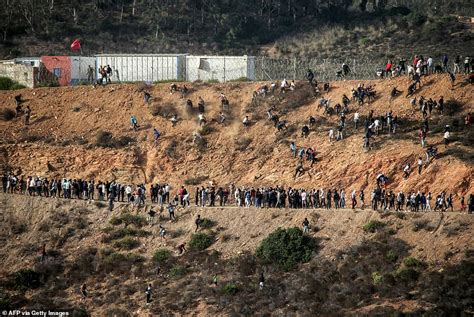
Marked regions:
[0,75,474,198]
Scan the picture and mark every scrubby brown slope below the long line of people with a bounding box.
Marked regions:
[0,194,474,316]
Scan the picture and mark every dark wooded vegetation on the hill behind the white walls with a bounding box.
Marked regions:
[0,0,473,57]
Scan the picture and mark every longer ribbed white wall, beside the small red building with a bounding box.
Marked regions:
[96,54,185,82]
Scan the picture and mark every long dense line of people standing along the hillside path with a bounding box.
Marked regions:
[2,174,474,212]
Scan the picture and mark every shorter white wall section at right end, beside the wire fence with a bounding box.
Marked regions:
[186,56,255,82]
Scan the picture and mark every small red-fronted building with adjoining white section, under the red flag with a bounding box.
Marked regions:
[40,56,96,86]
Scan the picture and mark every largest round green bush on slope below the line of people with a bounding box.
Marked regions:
[255,227,315,271]
